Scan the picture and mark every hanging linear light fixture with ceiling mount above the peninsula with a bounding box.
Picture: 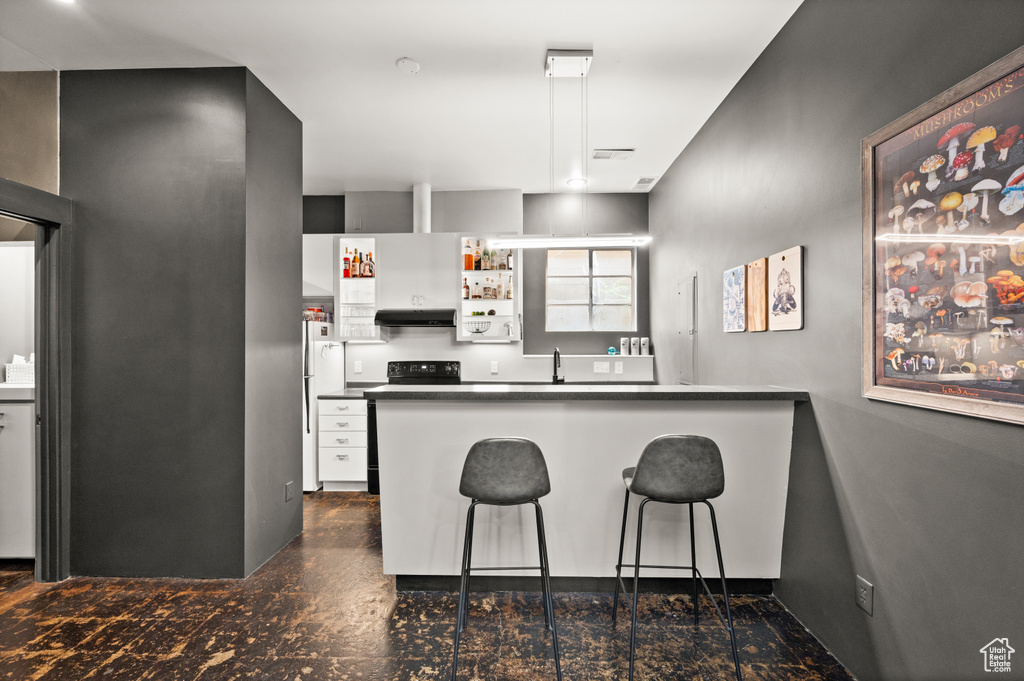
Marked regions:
[493,49,650,248]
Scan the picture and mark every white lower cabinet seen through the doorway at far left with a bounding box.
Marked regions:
[0,402,36,558]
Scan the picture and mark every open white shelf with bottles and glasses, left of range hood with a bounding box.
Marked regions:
[334,237,388,341]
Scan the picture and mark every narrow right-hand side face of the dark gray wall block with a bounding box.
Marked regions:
[245,71,302,574]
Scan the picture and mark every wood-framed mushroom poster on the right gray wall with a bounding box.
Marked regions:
[864,42,1024,423]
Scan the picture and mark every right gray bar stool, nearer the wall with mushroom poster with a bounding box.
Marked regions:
[611,435,740,681]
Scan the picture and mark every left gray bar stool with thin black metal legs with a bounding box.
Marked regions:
[452,437,562,681]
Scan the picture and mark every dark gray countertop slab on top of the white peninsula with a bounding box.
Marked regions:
[365,383,810,401]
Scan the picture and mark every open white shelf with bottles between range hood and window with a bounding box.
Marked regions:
[456,237,521,342]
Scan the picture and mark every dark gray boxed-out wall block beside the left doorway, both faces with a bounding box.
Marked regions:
[60,68,301,578]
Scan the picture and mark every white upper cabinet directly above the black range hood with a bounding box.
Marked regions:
[376,233,459,309]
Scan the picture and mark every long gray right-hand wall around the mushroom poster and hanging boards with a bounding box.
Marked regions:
[650,0,1024,681]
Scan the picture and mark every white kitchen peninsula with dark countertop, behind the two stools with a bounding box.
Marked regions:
[366,384,808,579]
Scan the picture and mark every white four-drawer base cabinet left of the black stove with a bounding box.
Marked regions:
[316,398,369,492]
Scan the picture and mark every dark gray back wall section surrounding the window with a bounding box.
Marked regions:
[522,193,654,354]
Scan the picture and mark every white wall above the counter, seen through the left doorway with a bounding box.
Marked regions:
[0,242,36,380]
